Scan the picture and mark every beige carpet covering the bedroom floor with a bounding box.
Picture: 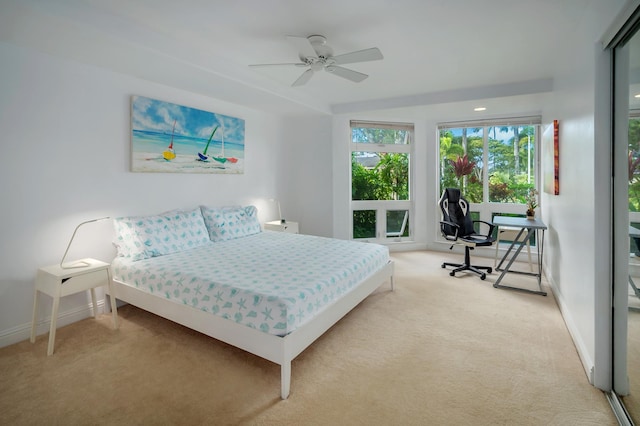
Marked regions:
[0,252,617,425]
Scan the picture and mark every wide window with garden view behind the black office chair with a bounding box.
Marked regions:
[438,117,540,240]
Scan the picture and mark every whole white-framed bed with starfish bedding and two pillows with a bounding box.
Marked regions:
[111,206,393,399]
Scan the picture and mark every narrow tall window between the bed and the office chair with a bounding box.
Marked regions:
[351,121,413,242]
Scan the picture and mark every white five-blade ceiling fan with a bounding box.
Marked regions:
[249,35,383,86]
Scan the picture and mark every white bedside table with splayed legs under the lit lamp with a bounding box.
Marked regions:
[30,259,118,355]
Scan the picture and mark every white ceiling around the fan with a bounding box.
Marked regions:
[0,0,622,113]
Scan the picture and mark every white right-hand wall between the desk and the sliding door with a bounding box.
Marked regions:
[542,4,615,390]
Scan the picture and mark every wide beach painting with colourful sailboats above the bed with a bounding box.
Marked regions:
[131,96,244,174]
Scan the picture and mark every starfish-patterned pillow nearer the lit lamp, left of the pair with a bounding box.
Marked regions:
[113,208,210,260]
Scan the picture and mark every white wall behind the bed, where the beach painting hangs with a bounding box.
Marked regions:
[0,43,302,346]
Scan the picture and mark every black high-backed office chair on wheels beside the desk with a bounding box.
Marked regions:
[439,188,495,280]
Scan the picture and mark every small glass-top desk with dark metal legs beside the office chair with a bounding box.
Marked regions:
[493,216,547,296]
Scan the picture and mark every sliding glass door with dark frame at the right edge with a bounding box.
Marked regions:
[610,6,640,424]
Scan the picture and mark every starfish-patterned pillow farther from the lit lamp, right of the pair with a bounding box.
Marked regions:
[202,206,262,242]
